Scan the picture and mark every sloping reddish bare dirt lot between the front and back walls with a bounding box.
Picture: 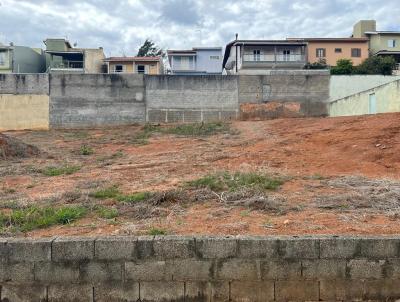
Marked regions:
[0,114,400,237]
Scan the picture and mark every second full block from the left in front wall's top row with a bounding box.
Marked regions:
[52,238,94,261]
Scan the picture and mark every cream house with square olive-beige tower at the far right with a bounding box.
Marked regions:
[353,20,400,66]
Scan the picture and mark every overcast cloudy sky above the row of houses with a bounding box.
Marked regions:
[0,0,400,56]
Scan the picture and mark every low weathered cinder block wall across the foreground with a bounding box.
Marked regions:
[0,236,400,302]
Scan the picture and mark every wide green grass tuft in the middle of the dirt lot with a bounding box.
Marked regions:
[186,172,283,192]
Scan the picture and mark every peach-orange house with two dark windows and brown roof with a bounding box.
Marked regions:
[288,37,369,66]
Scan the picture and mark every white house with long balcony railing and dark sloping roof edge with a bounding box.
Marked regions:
[222,39,307,74]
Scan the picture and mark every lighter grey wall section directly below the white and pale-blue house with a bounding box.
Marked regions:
[145,75,239,123]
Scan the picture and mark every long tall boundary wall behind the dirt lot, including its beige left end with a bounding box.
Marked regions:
[0,71,330,130]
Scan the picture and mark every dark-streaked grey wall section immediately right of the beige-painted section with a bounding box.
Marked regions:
[49,74,146,128]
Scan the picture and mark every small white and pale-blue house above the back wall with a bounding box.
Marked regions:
[167,47,222,75]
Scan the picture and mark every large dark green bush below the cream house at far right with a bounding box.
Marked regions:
[354,56,396,75]
